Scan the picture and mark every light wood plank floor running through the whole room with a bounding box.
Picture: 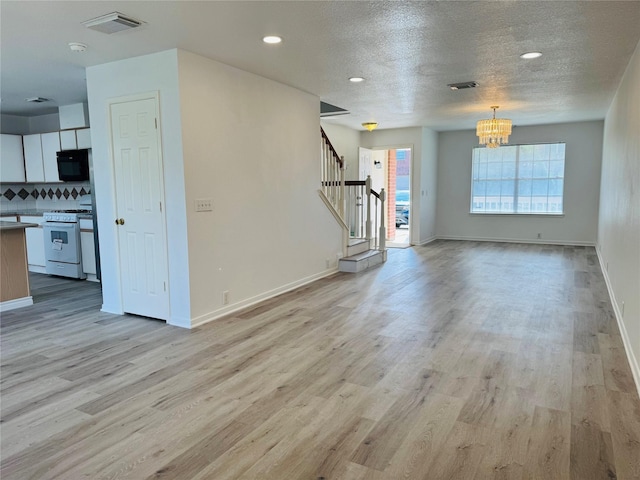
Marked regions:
[0,241,640,480]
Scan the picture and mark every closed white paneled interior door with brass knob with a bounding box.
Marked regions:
[110,98,169,320]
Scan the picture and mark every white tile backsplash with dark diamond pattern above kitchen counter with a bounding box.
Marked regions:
[0,182,91,212]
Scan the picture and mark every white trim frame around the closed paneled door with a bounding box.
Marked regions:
[107,90,171,323]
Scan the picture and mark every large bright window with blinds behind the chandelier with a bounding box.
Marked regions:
[471,143,565,215]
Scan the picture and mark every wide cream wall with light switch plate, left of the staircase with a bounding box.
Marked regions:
[178,51,342,324]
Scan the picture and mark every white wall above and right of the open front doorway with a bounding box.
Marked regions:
[360,127,437,245]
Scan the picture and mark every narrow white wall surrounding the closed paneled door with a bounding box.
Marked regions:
[87,50,191,326]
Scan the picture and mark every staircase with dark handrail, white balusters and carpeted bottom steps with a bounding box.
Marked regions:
[318,128,387,273]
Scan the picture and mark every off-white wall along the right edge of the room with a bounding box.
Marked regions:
[598,39,640,391]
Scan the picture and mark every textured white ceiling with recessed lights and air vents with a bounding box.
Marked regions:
[0,0,640,130]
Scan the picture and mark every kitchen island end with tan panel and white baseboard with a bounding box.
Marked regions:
[0,221,38,312]
